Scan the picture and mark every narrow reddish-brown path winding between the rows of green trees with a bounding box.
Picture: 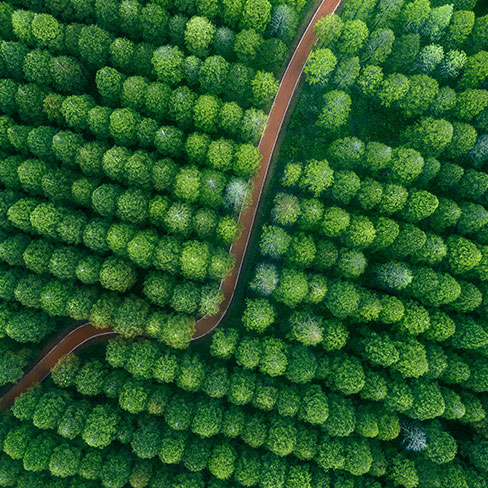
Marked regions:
[0,0,341,410]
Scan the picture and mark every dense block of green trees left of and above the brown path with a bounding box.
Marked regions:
[0,0,306,366]
